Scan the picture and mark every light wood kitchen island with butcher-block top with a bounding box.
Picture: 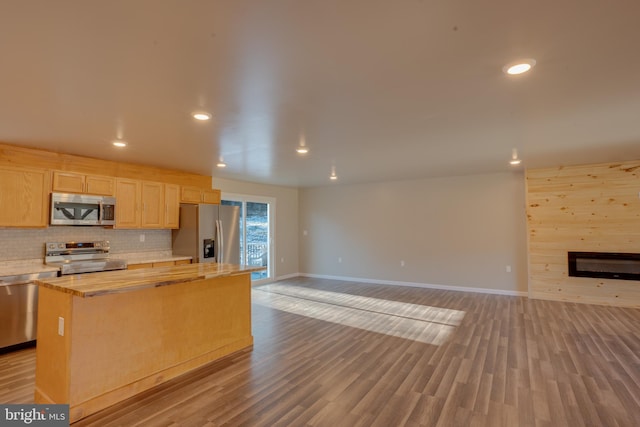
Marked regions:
[35,263,264,422]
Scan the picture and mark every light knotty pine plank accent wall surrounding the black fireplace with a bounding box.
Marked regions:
[526,160,640,308]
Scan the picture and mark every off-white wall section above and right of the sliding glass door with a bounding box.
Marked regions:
[213,177,298,278]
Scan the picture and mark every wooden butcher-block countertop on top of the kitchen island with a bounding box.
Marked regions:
[36,263,265,298]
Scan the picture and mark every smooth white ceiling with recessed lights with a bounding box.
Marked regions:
[0,0,640,187]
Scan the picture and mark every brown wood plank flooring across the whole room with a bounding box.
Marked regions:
[0,278,640,427]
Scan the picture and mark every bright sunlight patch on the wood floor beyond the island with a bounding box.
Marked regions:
[252,284,465,345]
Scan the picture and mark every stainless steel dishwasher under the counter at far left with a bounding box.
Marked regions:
[0,271,58,349]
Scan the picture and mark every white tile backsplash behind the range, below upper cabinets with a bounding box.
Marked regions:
[0,226,171,261]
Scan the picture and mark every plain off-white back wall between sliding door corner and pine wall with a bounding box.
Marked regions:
[300,173,527,293]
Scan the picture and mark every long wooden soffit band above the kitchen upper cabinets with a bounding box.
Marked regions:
[0,143,212,188]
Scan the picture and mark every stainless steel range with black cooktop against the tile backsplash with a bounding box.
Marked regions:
[44,240,127,276]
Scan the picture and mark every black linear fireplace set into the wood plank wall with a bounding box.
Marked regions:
[568,252,640,280]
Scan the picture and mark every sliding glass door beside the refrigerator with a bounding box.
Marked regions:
[221,194,275,283]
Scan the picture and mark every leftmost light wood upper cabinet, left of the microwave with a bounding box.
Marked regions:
[0,166,51,227]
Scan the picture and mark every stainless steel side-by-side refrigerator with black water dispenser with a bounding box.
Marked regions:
[172,204,240,264]
